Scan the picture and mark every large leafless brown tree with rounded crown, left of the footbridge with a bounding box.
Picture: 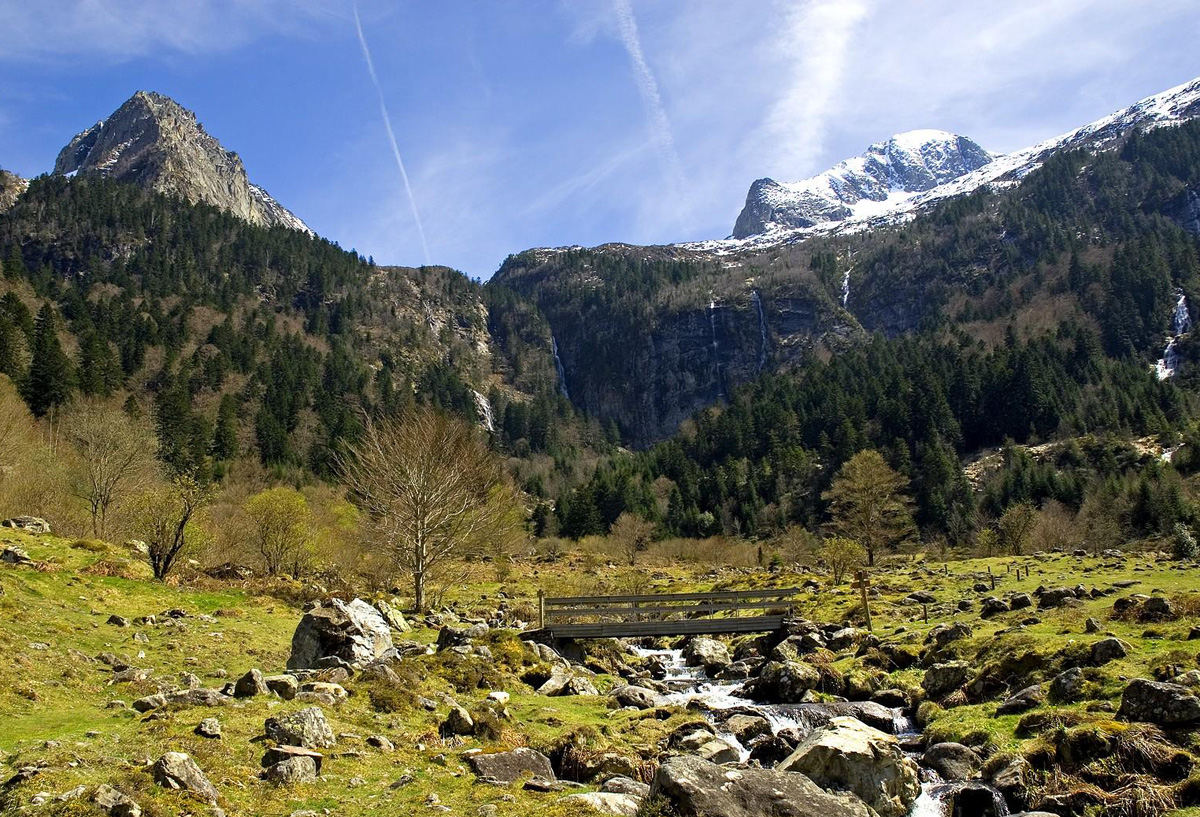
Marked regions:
[337,408,517,612]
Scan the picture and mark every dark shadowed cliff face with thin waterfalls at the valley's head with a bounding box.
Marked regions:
[492,245,862,446]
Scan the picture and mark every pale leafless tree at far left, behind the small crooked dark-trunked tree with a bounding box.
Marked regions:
[64,401,154,539]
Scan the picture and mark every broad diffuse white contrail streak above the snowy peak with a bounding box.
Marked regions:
[768,0,870,174]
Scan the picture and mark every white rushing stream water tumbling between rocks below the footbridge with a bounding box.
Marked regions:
[632,647,1008,817]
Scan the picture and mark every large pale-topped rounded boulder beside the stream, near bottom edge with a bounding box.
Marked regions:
[779,717,920,817]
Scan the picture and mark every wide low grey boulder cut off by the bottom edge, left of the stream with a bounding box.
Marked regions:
[650,756,874,817]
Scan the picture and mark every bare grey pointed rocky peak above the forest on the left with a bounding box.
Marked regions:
[54,91,311,233]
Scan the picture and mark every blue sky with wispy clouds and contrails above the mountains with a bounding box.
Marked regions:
[0,0,1200,277]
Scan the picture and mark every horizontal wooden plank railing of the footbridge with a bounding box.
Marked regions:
[538,588,802,629]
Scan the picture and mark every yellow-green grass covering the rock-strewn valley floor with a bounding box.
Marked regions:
[0,531,1200,817]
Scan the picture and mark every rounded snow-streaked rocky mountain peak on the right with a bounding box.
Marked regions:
[733,130,994,239]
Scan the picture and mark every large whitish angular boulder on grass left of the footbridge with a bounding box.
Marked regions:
[288,599,391,669]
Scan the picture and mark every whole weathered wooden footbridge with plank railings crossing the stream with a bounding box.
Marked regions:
[538,588,800,638]
